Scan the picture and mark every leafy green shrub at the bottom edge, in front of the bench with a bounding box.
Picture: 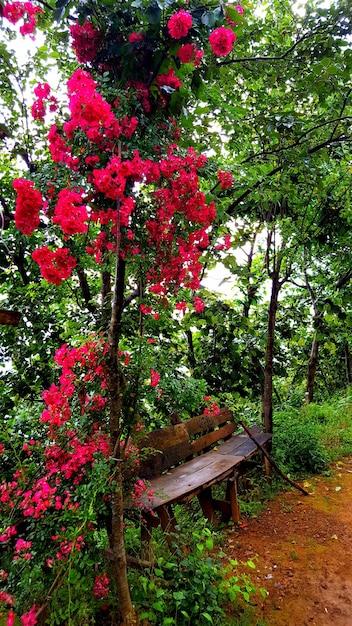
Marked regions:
[131,526,256,626]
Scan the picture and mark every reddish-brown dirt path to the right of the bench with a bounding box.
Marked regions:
[224,459,352,626]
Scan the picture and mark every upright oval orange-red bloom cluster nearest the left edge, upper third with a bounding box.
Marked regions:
[12,178,43,235]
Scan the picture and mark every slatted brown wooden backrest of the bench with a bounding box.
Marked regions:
[138,409,237,478]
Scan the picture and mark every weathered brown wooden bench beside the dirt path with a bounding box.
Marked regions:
[138,409,272,557]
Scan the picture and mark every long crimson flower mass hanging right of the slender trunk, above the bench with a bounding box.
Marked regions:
[146,148,216,295]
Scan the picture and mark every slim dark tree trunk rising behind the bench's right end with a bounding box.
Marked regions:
[262,266,281,433]
